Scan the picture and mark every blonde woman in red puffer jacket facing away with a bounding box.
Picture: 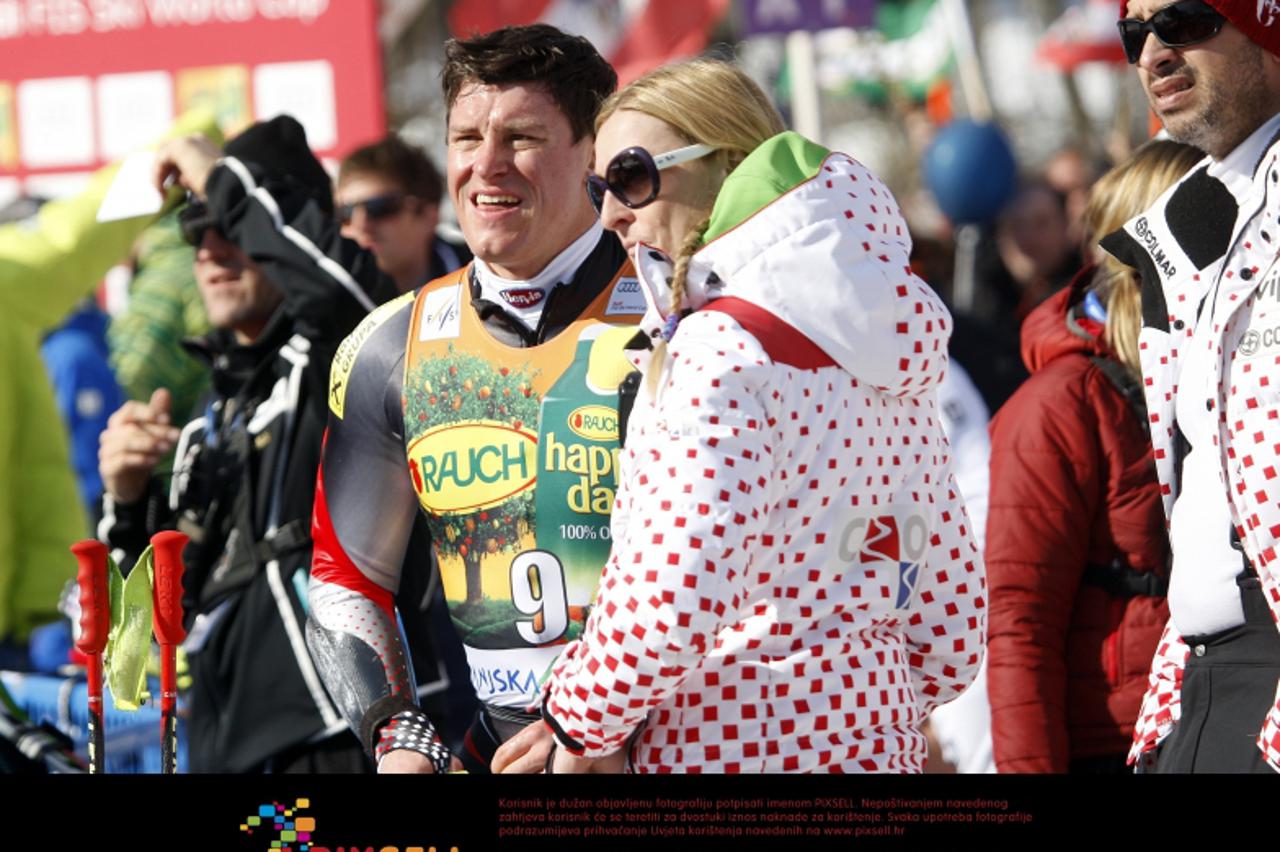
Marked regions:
[986,142,1203,773]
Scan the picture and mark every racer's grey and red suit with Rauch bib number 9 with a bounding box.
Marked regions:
[308,235,644,770]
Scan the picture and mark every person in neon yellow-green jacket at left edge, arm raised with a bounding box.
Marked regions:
[0,113,221,665]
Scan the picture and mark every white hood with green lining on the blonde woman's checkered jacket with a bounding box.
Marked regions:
[635,132,951,395]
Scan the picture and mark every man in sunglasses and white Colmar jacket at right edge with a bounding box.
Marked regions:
[1102,0,1280,773]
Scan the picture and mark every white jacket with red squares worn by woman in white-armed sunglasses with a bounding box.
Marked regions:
[543,133,986,773]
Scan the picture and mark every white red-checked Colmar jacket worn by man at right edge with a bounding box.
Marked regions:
[1103,124,1280,771]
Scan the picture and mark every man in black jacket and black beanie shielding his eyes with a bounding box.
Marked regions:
[100,116,396,771]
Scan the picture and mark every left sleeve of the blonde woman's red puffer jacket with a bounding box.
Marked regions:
[986,365,1101,773]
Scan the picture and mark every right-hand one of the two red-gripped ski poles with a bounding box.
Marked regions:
[151,531,187,775]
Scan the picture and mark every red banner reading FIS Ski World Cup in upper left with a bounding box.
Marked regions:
[0,0,385,203]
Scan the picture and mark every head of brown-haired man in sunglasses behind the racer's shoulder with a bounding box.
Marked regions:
[334,134,471,293]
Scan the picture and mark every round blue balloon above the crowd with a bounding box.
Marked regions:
[923,119,1018,225]
